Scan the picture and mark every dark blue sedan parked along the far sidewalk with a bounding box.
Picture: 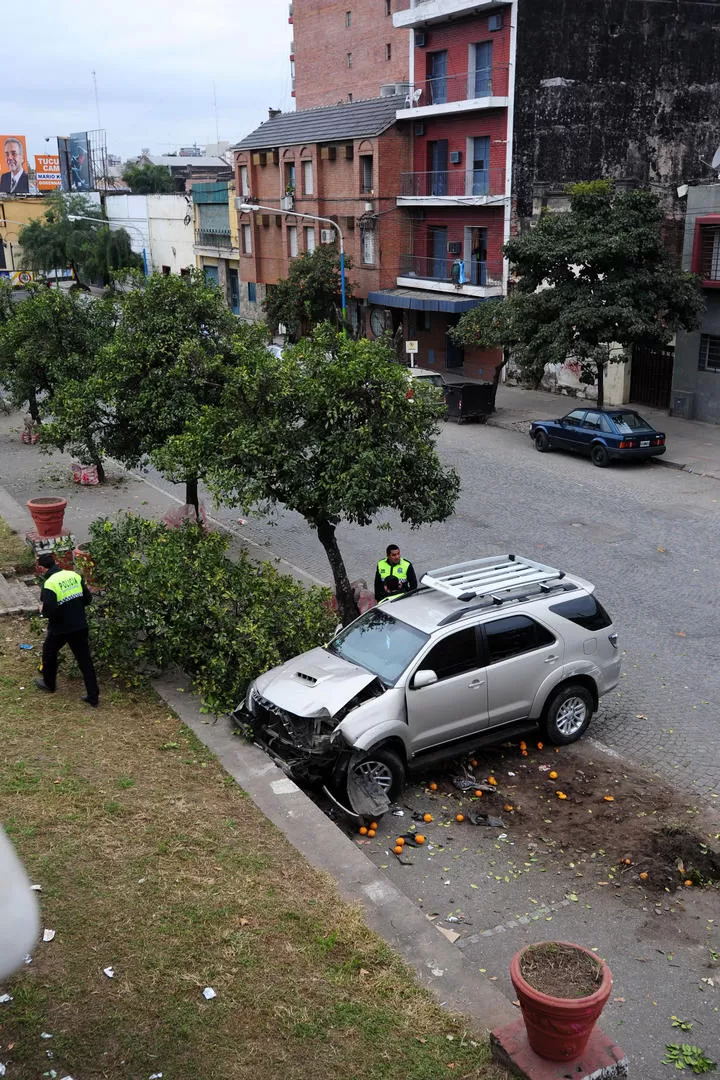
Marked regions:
[530,406,665,469]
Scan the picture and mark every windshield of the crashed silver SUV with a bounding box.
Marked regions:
[326,608,429,686]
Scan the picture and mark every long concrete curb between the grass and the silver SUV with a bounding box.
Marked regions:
[153,675,517,1031]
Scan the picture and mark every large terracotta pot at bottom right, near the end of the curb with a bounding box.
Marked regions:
[510,942,612,1062]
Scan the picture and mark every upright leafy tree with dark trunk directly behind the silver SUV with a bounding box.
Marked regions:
[156,326,460,623]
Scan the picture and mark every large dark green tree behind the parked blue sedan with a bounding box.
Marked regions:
[451,180,703,406]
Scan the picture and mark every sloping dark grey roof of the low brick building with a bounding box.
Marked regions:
[232,95,400,150]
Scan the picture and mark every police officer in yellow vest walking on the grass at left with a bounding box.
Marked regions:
[35,555,99,707]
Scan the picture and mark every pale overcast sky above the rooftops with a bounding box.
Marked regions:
[5,0,294,163]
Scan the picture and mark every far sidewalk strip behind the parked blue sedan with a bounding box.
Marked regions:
[488,383,720,480]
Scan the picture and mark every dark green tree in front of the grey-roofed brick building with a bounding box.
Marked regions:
[264,244,354,341]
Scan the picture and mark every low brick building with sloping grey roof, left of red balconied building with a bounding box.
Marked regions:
[233,97,410,334]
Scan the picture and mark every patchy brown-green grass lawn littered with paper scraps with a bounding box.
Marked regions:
[0,619,505,1080]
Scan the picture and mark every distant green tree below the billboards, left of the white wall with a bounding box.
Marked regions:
[18,193,142,285]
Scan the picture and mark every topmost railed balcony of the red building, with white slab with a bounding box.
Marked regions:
[397,64,510,120]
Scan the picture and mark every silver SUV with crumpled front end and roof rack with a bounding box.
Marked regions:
[234,555,621,814]
